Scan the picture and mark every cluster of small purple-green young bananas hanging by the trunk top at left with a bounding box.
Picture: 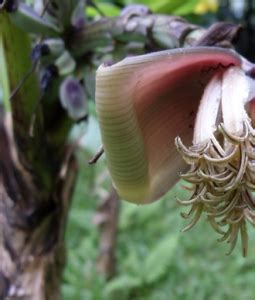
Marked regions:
[0,0,87,122]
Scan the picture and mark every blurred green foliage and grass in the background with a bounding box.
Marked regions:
[63,0,255,300]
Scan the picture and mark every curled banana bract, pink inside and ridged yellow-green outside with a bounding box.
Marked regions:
[96,47,241,204]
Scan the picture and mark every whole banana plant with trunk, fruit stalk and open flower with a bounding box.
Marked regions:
[0,0,249,300]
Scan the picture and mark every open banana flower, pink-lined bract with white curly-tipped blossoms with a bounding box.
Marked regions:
[96,47,255,255]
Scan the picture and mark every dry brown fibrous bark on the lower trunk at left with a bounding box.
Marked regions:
[0,113,76,300]
